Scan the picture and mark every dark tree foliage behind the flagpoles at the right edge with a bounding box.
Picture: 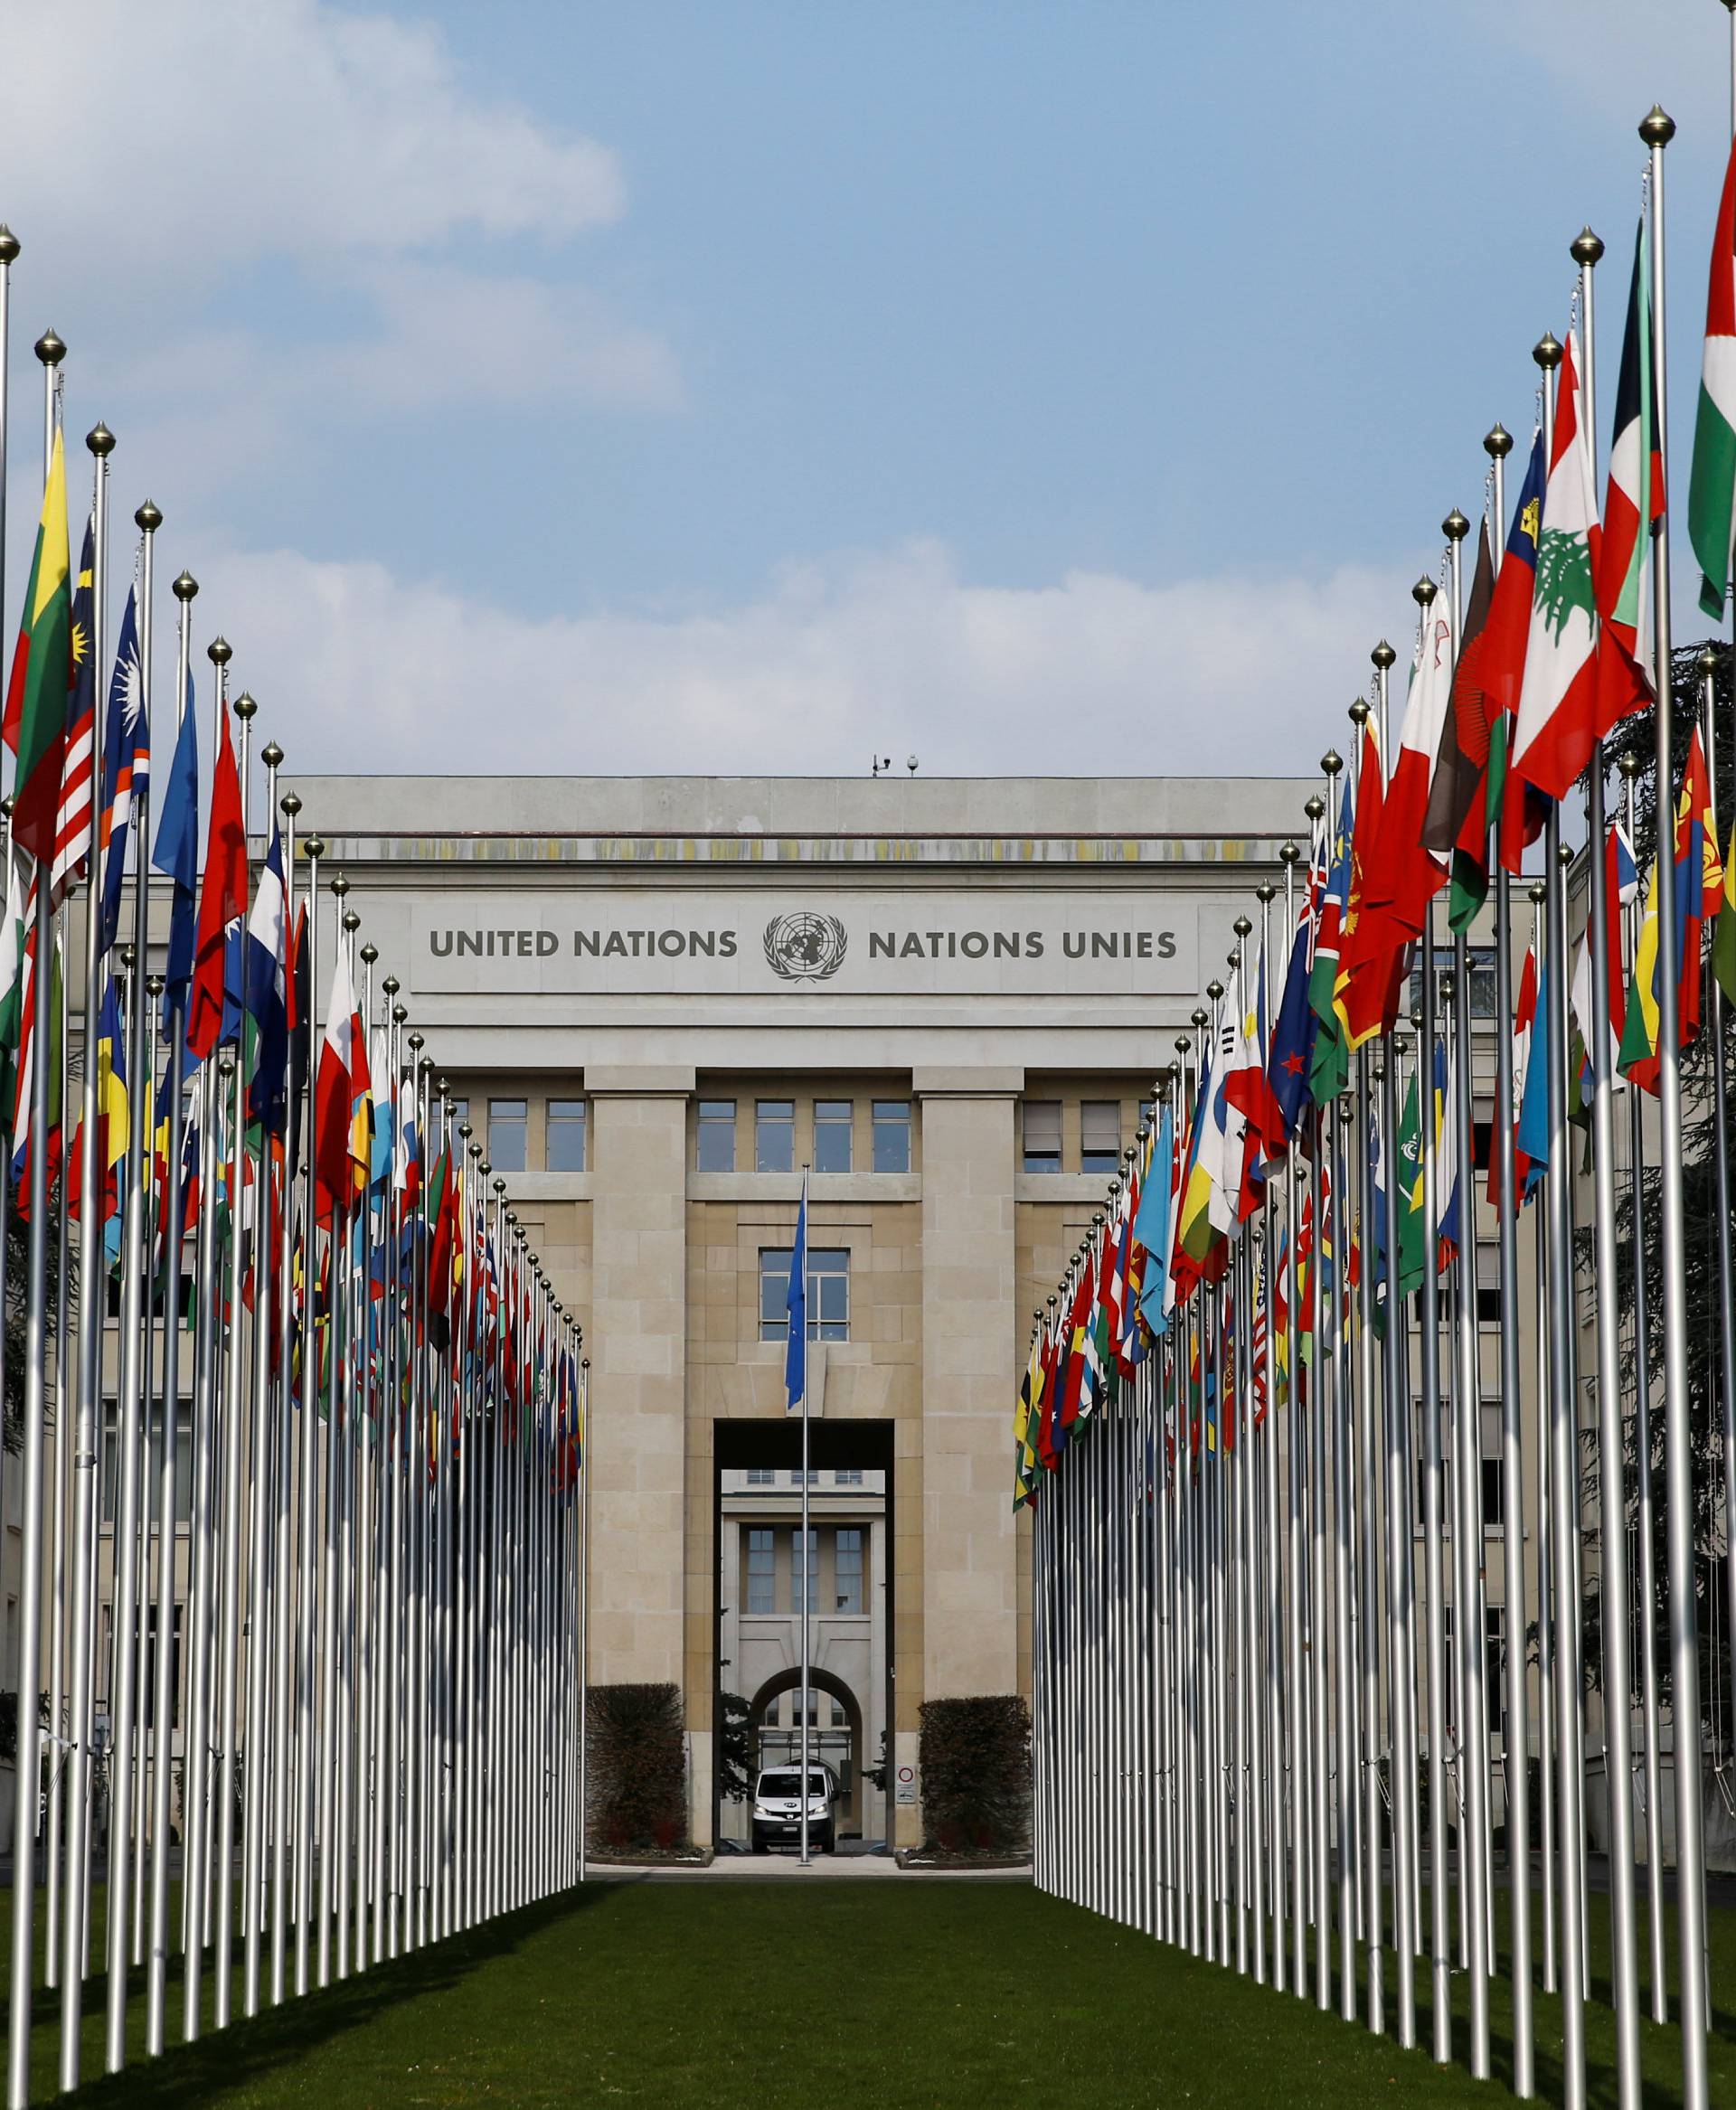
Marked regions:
[1576,639,1736,1729]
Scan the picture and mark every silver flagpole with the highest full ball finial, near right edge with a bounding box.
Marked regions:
[1639,103,1706,2110]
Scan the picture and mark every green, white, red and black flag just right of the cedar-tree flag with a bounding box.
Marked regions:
[1597,220,1665,739]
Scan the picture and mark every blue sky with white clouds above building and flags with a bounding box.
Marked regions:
[0,0,1730,775]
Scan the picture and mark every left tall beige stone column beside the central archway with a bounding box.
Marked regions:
[584,1068,694,1686]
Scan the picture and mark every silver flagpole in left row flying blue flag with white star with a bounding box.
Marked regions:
[105,497,163,2074]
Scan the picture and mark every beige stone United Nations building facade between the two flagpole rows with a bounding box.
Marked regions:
[284,777,1310,1846]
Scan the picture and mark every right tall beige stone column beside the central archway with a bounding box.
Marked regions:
[913,1069,1025,1700]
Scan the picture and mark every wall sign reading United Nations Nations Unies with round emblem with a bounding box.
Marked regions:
[410,889,1198,996]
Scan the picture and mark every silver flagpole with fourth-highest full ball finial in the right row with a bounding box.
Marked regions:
[1483,411,1535,2099]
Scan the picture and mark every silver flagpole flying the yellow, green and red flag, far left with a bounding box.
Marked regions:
[6,331,65,2110]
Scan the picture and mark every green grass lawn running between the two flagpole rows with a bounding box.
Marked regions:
[0,1878,1736,2110]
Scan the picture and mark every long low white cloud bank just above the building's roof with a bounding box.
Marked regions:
[203,542,1405,775]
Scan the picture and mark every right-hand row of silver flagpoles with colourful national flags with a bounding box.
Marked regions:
[1014,57,1736,2110]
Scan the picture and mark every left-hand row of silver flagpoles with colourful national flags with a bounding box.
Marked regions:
[0,276,589,2105]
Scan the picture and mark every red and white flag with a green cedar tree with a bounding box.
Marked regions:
[1508,329,1599,818]
